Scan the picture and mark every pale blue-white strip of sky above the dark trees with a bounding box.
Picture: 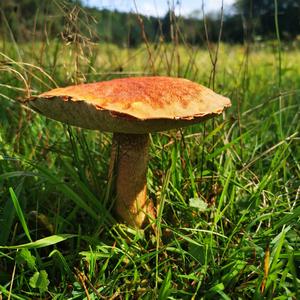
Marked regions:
[83,0,235,17]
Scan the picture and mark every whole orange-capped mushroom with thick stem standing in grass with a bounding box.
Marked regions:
[26,76,231,228]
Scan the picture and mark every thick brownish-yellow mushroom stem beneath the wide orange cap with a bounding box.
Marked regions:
[111,133,155,228]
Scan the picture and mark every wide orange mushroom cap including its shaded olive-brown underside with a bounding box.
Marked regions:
[27,76,231,133]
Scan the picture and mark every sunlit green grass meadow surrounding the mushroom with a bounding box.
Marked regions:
[0,17,300,299]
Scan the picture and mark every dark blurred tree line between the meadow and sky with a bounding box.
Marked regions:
[0,0,300,47]
